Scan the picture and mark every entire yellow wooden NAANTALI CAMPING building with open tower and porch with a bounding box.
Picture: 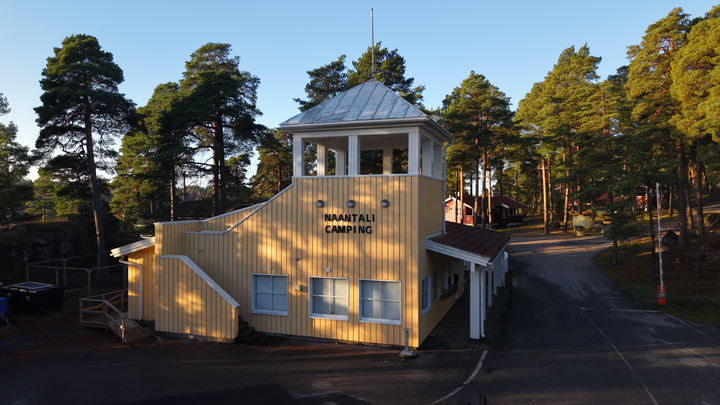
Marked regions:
[112,80,509,347]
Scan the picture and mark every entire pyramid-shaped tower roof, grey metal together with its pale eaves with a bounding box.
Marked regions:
[279,79,452,142]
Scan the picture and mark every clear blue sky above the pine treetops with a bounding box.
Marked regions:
[0,0,720,178]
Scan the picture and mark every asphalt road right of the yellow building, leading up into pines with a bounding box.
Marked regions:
[473,236,720,405]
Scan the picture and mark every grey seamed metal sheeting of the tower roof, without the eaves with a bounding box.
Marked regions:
[280,79,427,126]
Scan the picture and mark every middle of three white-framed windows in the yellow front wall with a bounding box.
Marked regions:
[309,277,348,321]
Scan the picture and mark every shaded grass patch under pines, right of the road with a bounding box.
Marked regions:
[594,229,720,327]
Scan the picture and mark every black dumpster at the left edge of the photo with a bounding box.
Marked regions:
[0,281,65,314]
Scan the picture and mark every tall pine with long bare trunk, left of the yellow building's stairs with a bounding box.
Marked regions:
[35,35,134,263]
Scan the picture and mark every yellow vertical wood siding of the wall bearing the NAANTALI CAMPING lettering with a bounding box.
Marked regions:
[156,176,443,346]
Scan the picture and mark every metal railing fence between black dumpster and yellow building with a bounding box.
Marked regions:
[25,253,127,295]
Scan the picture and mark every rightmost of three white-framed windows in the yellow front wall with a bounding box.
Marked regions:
[359,279,401,325]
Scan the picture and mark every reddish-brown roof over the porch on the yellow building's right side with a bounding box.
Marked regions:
[433,221,510,259]
